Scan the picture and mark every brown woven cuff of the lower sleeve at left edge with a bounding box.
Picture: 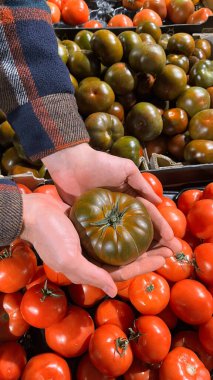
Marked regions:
[0,178,22,247]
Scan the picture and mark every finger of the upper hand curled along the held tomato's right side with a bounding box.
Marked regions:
[137,197,174,241]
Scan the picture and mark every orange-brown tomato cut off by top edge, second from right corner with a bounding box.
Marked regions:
[167,0,195,24]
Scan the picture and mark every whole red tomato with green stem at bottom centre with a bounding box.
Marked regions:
[89,324,133,377]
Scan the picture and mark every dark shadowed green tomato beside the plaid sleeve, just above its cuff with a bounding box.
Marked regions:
[67,50,101,80]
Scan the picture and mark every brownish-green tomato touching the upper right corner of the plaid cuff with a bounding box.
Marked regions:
[76,78,115,115]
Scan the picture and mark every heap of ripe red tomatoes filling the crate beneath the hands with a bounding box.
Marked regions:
[0,173,213,380]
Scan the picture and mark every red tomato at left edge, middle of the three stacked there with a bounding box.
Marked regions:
[0,292,29,342]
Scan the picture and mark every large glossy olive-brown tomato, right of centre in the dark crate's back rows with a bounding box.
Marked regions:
[129,43,166,75]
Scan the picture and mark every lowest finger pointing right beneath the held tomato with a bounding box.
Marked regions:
[105,255,165,281]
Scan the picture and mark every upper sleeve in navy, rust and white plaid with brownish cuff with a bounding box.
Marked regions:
[0,0,89,160]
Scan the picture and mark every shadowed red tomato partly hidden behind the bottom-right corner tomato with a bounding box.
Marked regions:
[172,330,213,371]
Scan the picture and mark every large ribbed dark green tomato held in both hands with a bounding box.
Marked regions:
[70,188,153,266]
